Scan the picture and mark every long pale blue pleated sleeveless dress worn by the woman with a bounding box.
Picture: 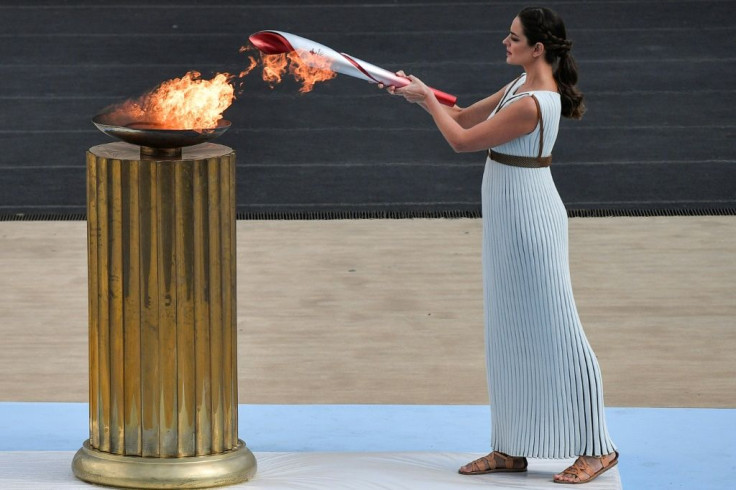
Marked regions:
[482,75,615,458]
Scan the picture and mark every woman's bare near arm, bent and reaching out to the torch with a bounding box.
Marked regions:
[394,75,537,152]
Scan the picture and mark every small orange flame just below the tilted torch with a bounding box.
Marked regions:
[251,51,337,93]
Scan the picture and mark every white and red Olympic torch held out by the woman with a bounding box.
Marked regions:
[249,31,457,107]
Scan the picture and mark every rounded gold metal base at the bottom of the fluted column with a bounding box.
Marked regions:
[72,440,257,488]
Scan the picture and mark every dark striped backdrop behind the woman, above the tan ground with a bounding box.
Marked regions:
[0,0,736,219]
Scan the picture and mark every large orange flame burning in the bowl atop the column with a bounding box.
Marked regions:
[105,71,235,131]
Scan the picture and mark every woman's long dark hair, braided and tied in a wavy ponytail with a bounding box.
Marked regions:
[518,7,585,119]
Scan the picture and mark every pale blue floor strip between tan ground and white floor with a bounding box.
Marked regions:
[0,402,736,490]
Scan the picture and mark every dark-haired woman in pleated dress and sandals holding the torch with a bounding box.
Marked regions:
[388,8,618,483]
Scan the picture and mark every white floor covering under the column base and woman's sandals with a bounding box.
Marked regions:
[0,451,622,490]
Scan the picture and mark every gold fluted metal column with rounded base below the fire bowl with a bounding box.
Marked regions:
[73,143,255,488]
